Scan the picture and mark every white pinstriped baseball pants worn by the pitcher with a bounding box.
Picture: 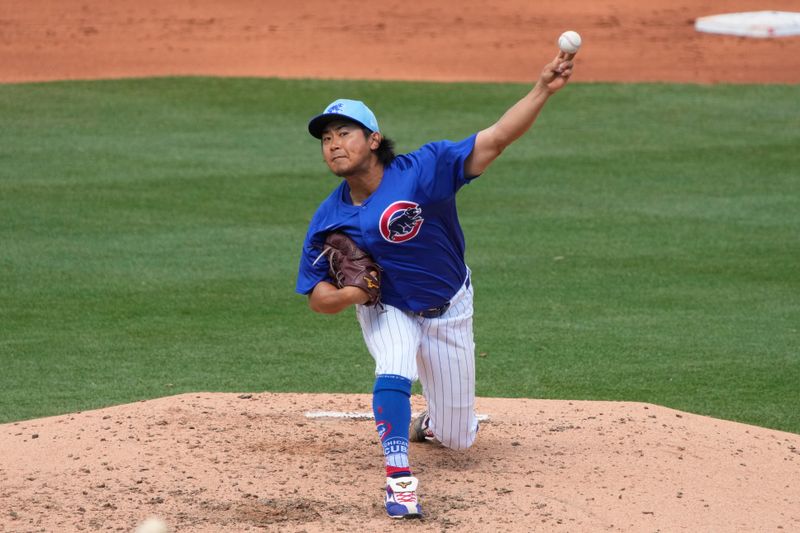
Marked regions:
[356,274,478,450]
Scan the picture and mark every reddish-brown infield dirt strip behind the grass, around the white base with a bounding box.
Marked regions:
[0,0,800,83]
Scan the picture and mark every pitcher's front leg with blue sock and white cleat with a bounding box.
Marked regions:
[356,306,421,518]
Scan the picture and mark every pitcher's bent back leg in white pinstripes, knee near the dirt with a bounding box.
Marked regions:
[418,283,478,450]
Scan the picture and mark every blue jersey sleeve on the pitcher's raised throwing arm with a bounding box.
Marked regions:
[408,134,477,201]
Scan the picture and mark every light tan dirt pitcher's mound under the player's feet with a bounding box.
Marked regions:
[0,393,800,532]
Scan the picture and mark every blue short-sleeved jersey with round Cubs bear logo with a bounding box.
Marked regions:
[296,131,475,312]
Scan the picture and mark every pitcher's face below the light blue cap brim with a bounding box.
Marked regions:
[322,121,380,177]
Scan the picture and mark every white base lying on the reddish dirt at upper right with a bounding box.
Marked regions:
[694,11,800,39]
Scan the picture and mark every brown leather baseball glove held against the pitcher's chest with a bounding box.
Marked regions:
[322,231,381,305]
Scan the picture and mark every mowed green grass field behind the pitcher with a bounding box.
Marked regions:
[0,78,800,432]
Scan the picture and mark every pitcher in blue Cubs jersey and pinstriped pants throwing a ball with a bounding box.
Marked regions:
[296,52,573,518]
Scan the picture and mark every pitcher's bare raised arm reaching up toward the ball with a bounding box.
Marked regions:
[464,52,574,176]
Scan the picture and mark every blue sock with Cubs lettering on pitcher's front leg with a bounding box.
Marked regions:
[372,374,411,477]
